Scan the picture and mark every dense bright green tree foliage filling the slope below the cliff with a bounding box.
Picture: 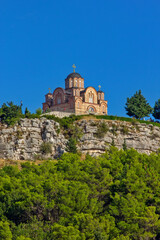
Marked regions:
[0,147,160,240]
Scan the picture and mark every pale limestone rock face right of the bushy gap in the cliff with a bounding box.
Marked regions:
[78,120,160,156]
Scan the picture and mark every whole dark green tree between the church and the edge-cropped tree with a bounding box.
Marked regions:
[125,90,153,119]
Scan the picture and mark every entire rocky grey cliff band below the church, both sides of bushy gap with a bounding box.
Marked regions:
[0,118,160,160]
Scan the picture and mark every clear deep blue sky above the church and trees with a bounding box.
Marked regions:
[0,0,160,116]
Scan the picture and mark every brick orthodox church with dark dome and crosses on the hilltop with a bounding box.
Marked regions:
[43,65,107,115]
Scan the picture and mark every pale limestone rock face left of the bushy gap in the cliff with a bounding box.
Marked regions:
[0,118,67,160]
